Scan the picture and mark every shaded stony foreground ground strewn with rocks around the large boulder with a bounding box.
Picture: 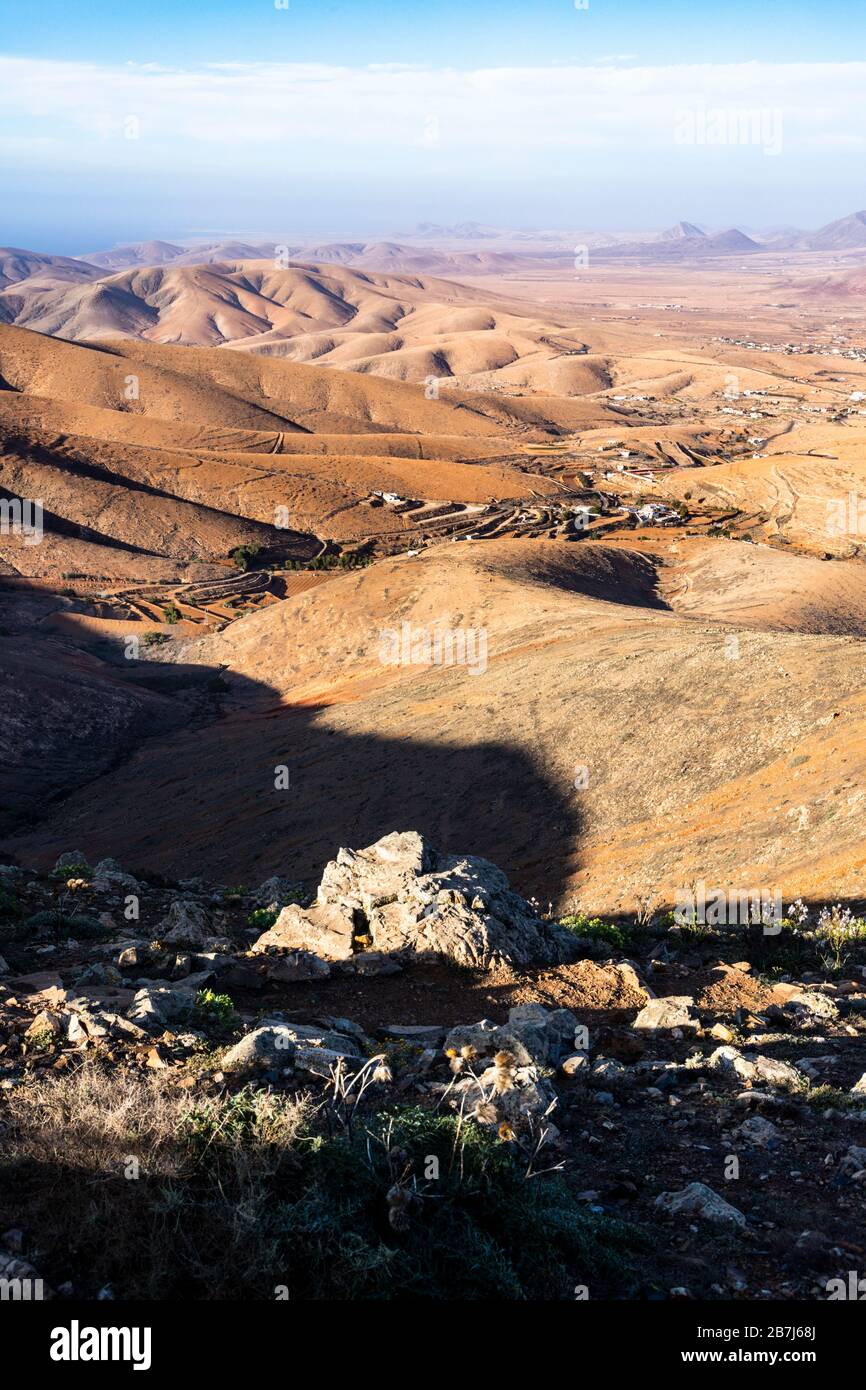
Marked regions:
[0,855,866,1300]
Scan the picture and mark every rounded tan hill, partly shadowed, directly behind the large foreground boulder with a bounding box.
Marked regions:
[11,542,866,910]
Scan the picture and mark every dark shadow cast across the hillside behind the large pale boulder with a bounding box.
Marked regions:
[0,581,580,904]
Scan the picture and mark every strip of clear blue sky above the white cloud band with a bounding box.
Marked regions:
[0,0,866,67]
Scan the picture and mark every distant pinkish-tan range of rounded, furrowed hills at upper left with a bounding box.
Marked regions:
[0,257,608,396]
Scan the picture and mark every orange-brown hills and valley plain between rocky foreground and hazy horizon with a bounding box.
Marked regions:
[0,252,866,912]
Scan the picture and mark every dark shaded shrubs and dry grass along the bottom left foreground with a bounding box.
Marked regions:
[0,1065,645,1301]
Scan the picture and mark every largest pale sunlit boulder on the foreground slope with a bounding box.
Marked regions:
[253,831,580,967]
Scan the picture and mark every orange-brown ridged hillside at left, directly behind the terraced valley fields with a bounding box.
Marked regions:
[0,325,583,581]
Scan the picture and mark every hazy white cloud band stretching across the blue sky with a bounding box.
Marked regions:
[0,54,866,177]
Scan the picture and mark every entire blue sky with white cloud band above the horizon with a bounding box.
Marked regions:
[0,0,866,254]
